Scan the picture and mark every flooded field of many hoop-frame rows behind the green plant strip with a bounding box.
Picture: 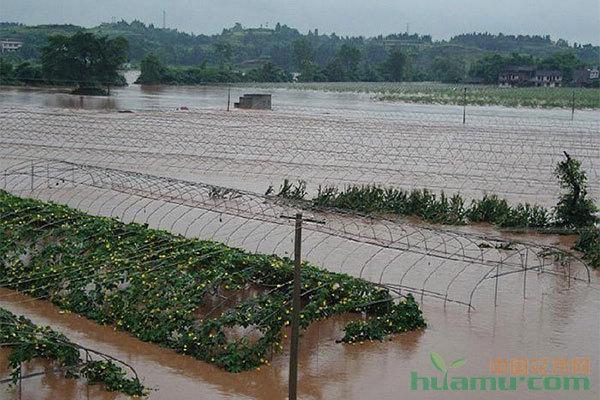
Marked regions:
[0,99,600,206]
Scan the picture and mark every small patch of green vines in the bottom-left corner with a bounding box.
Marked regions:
[0,308,146,396]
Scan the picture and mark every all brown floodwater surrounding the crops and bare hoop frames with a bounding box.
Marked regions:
[0,78,600,400]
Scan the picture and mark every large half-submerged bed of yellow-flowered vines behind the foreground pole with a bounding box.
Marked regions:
[0,191,425,372]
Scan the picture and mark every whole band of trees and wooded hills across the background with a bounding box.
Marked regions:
[0,21,599,86]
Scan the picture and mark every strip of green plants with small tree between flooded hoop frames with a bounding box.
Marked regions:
[274,153,600,268]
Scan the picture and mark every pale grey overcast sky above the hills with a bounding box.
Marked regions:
[0,0,600,44]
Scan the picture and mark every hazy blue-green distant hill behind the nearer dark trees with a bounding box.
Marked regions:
[0,21,600,77]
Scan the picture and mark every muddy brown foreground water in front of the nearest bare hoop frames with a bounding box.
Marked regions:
[0,250,600,399]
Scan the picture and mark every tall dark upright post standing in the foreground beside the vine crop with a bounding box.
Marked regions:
[288,213,302,400]
